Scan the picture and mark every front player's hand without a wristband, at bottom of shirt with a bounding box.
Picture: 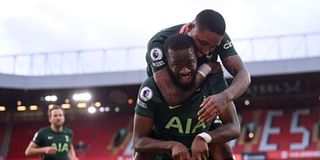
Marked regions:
[171,143,191,160]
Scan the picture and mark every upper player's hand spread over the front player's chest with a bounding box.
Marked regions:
[198,93,228,122]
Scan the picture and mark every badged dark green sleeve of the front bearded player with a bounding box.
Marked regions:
[135,78,155,119]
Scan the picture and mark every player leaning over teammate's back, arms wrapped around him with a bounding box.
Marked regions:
[146,9,251,121]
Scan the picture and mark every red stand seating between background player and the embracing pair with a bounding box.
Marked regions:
[70,114,132,159]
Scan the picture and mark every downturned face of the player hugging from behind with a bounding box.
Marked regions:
[188,25,223,57]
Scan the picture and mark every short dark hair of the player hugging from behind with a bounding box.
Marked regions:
[195,9,226,36]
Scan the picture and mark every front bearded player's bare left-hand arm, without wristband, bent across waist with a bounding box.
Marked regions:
[133,114,190,160]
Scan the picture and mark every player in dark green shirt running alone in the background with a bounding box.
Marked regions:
[25,105,78,160]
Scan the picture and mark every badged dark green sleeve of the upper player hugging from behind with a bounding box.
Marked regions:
[146,40,166,76]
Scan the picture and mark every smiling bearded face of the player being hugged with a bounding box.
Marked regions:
[168,48,197,87]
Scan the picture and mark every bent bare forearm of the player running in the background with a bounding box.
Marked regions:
[25,141,57,156]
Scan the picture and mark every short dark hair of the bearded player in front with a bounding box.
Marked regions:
[164,34,197,57]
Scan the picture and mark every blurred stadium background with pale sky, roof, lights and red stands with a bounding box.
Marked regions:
[0,0,320,160]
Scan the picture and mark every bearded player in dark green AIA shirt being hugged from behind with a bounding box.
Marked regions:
[133,34,240,160]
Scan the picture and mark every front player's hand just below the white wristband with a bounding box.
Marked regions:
[191,136,209,160]
